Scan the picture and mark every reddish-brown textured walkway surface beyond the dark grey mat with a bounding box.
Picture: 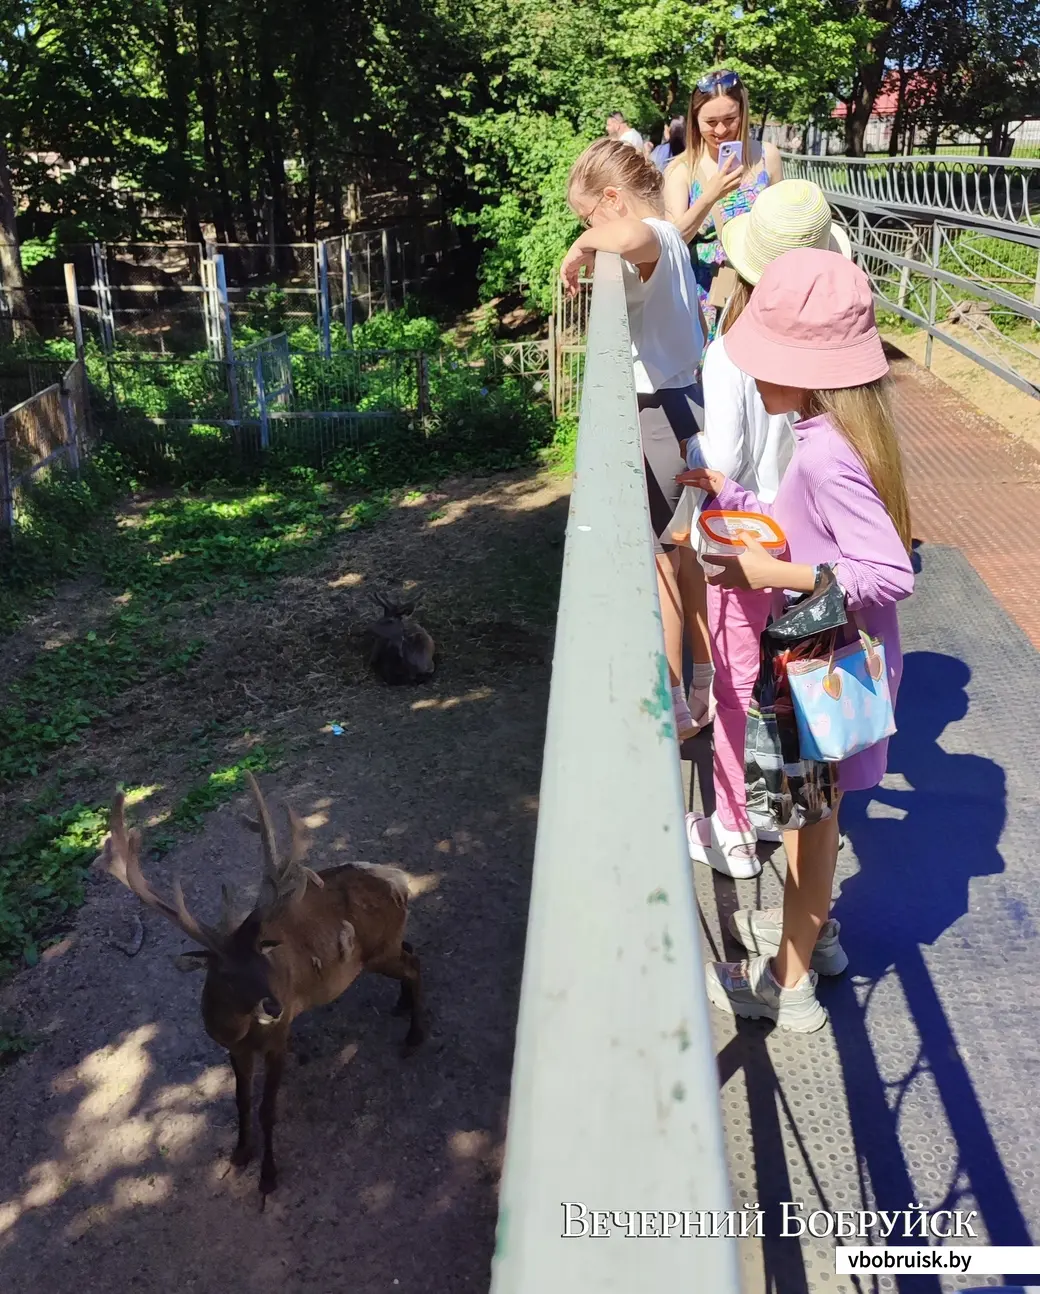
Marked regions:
[893,356,1040,650]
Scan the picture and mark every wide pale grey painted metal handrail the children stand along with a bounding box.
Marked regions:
[492,252,740,1294]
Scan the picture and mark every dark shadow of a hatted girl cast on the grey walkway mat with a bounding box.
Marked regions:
[821,652,1031,1278]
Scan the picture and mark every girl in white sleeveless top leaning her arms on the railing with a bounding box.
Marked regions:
[560,140,710,741]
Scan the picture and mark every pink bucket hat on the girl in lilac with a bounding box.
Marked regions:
[723,247,889,391]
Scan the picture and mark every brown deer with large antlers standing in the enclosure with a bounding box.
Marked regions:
[102,774,424,1196]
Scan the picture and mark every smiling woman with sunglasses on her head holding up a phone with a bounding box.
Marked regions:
[665,71,783,342]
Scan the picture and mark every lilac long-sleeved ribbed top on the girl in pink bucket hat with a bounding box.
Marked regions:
[718,415,913,791]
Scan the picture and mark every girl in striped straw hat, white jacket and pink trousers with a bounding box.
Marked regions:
[684,180,852,879]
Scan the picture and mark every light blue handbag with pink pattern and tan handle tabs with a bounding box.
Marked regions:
[788,629,895,763]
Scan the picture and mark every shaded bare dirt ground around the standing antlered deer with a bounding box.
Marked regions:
[0,474,568,1294]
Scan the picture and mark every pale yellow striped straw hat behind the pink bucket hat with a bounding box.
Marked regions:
[722,180,852,285]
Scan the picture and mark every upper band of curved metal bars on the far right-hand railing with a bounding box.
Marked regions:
[783,153,1040,234]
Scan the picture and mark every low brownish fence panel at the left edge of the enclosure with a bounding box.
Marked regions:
[0,360,89,533]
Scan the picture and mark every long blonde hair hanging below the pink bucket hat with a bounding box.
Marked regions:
[808,378,912,553]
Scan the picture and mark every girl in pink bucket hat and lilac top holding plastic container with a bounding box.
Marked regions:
[679,248,913,1033]
